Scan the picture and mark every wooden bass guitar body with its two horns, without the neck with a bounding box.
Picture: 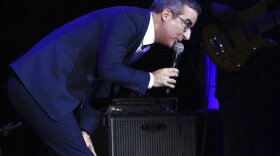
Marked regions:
[202,0,276,72]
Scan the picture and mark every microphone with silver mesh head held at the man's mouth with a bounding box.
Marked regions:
[165,43,184,94]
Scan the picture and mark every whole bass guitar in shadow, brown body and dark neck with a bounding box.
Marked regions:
[202,0,280,72]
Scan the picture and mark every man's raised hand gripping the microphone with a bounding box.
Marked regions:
[152,68,179,88]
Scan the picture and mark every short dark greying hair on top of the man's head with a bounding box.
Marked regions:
[150,0,201,17]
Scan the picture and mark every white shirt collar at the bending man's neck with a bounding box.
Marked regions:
[142,13,155,45]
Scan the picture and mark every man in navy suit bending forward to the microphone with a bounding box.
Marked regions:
[8,0,201,156]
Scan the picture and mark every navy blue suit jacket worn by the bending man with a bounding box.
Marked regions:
[10,6,150,122]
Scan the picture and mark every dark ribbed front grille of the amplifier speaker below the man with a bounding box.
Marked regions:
[110,116,196,156]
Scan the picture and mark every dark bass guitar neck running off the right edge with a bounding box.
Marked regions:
[249,9,280,34]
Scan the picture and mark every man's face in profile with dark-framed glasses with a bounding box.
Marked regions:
[158,5,198,47]
